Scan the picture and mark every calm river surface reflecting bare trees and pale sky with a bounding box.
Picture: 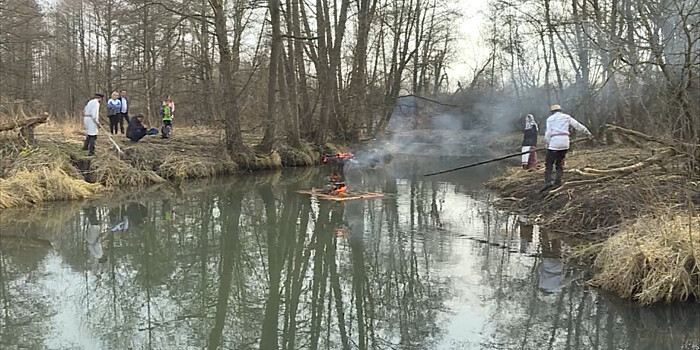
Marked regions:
[0,162,700,349]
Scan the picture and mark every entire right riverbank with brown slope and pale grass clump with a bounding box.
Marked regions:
[488,130,700,305]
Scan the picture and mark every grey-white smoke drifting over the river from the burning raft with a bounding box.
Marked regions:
[346,93,548,179]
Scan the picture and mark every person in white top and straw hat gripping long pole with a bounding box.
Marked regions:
[542,105,593,192]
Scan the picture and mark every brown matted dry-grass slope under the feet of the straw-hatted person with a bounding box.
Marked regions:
[488,147,686,235]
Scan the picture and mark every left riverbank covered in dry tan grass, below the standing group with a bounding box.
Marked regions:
[0,122,338,209]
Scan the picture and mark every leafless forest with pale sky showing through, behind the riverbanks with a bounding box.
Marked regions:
[0,0,700,159]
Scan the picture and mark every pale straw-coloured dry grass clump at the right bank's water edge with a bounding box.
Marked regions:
[575,213,700,305]
